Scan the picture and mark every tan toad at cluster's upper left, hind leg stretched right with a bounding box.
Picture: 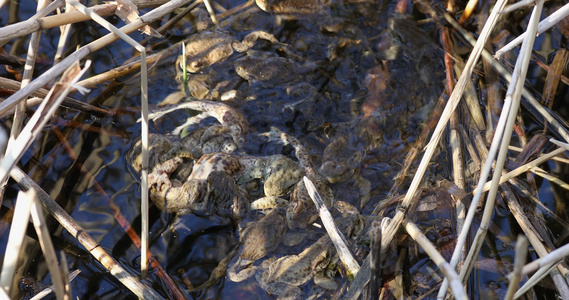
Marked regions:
[177,30,279,73]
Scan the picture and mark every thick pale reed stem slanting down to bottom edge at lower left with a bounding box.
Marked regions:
[10,167,163,299]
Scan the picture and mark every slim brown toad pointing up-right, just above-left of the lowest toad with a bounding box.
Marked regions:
[227,208,286,282]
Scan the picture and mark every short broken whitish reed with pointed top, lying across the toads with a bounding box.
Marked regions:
[303,176,360,278]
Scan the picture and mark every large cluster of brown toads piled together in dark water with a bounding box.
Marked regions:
[128,0,443,297]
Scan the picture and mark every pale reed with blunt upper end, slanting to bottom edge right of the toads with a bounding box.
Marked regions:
[405,220,468,299]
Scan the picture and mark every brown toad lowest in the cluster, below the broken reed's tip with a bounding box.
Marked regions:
[256,236,334,295]
